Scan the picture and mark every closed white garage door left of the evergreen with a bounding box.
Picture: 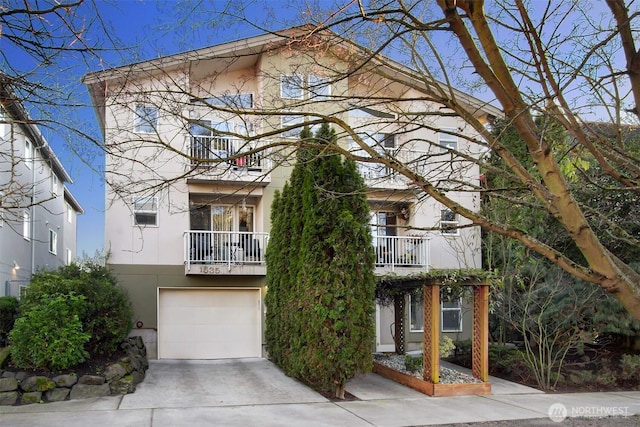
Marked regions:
[158,288,262,359]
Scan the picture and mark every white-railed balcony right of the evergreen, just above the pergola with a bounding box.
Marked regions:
[373,236,429,275]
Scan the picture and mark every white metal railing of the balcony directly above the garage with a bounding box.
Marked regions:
[184,231,269,266]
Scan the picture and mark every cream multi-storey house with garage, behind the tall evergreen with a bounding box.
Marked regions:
[84,29,500,359]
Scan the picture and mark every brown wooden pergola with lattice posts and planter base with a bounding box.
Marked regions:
[374,274,491,396]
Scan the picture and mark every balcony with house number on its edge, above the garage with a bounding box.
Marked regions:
[184,231,269,276]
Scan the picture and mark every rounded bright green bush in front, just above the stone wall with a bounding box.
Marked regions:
[9,293,91,370]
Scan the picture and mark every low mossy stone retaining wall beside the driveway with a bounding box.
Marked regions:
[0,336,149,405]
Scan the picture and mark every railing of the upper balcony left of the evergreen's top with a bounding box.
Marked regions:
[189,135,271,176]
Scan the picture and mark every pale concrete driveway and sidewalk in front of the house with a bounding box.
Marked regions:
[0,359,640,427]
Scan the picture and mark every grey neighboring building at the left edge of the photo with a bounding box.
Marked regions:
[0,81,83,296]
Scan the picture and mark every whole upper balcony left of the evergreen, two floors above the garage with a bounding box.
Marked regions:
[189,135,271,182]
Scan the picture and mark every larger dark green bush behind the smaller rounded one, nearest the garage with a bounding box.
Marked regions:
[23,262,132,356]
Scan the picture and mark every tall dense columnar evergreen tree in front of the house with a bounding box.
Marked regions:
[266,124,375,398]
